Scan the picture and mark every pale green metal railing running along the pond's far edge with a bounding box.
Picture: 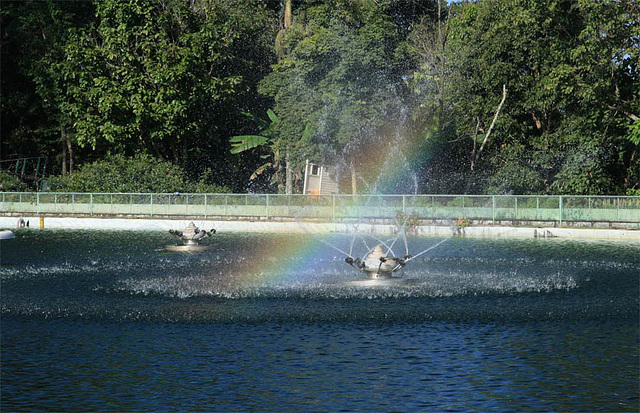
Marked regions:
[0,192,640,225]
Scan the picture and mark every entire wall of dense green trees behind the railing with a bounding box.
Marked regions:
[0,0,640,194]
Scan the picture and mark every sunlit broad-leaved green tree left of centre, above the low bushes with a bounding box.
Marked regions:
[66,1,268,165]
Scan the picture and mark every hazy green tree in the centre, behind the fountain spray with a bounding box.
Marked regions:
[260,1,412,193]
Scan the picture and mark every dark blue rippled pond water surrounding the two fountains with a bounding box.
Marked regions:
[0,230,640,412]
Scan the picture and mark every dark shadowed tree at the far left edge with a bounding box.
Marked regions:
[0,1,94,173]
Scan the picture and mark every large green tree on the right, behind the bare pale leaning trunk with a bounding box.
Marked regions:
[436,0,638,194]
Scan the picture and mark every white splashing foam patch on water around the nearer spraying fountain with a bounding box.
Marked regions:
[109,264,578,299]
